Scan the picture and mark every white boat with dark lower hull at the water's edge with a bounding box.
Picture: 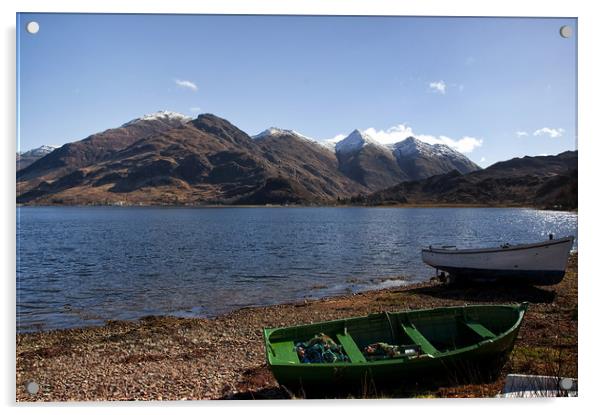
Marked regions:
[422,235,575,285]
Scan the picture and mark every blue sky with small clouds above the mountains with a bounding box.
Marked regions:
[17,14,577,166]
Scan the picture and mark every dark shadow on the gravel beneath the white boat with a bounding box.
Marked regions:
[407,283,556,304]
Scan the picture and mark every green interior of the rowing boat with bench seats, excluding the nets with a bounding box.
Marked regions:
[267,306,519,364]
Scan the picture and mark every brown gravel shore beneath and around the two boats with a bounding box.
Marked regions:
[16,254,577,401]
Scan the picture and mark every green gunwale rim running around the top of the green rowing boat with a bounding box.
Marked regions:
[263,302,528,368]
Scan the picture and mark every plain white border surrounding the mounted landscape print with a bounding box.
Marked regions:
[0,0,602,414]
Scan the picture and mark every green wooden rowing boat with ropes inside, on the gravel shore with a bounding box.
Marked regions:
[264,303,527,391]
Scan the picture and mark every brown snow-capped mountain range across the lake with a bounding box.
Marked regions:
[17,111,568,205]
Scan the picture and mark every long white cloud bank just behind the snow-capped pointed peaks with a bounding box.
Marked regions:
[326,124,483,153]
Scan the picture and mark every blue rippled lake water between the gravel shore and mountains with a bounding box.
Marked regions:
[17,207,577,330]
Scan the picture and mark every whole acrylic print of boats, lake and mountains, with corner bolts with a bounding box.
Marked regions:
[16,13,578,401]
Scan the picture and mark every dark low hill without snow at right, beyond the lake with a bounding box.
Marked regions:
[351,151,577,209]
